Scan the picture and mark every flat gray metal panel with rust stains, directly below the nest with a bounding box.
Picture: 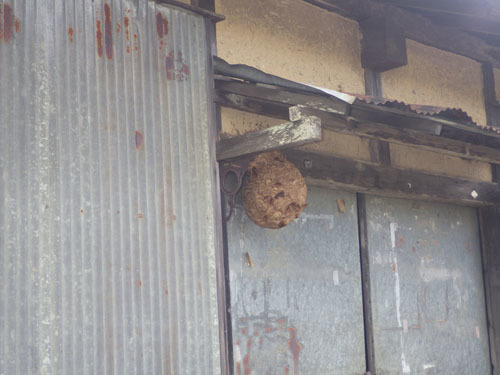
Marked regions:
[228,188,365,375]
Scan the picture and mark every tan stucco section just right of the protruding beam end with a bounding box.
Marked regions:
[382,40,486,124]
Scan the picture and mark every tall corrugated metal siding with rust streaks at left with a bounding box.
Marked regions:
[0,0,220,375]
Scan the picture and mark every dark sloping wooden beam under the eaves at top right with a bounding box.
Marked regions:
[305,0,500,68]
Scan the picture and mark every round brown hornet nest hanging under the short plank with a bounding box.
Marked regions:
[243,151,307,229]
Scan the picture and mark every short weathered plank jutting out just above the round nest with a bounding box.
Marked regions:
[217,116,322,161]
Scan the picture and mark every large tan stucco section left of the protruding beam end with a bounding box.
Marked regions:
[216,0,365,93]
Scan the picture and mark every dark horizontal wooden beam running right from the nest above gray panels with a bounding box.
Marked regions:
[283,149,500,206]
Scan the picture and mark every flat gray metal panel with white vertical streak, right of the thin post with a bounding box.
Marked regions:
[366,196,490,375]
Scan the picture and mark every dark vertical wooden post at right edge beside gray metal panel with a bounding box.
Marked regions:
[479,206,500,375]
